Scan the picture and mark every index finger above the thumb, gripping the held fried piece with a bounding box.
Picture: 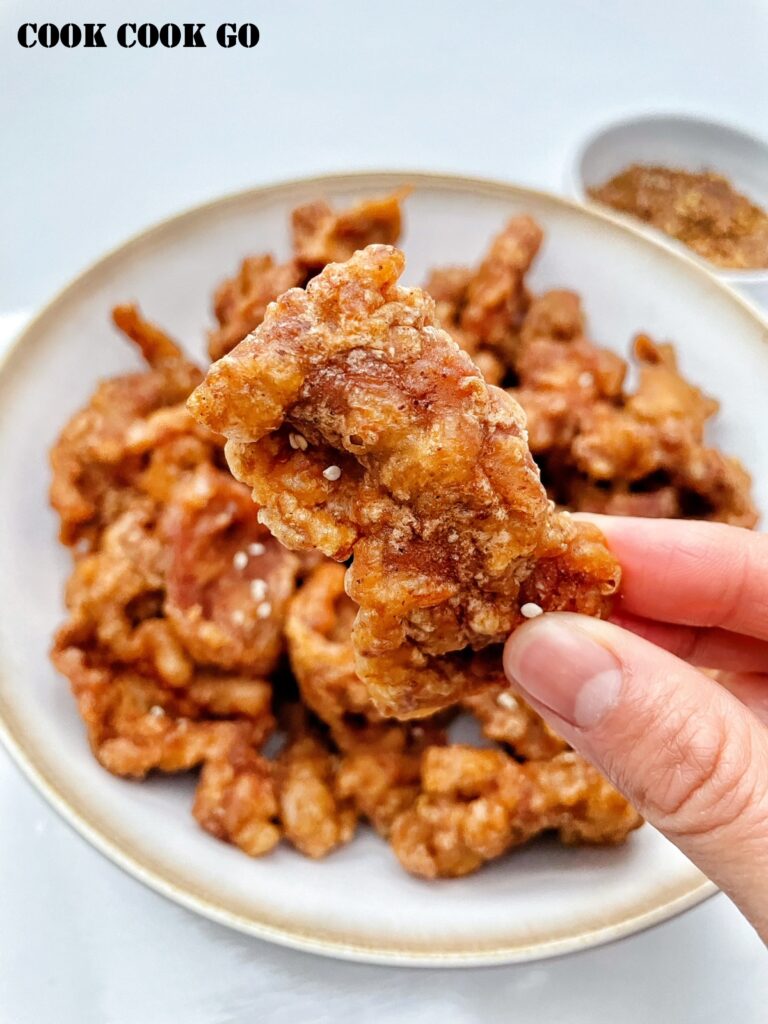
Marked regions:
[584,515,768,640]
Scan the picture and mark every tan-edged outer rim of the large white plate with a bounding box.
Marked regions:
[0,169,768,967]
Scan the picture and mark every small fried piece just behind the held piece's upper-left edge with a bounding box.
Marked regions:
[208,253,306,360]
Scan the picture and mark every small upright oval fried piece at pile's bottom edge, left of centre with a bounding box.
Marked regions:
[274,729,357,858]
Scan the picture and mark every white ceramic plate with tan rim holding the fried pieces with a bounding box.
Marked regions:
[0,174,768,966]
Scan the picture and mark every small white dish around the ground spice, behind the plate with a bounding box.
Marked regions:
[568,114,768,305]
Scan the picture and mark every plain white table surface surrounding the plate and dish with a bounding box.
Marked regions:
[0,0,768,1024]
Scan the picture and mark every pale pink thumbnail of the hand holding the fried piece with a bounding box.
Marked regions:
[504,613,622,729]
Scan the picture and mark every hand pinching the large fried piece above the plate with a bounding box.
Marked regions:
[504,516,768,941]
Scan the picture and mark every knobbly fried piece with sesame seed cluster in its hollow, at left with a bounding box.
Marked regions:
[54,465,298,687]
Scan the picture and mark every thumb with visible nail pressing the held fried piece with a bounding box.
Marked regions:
[504,612,768,939]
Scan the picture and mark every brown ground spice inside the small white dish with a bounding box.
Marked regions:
[589,164,768,270]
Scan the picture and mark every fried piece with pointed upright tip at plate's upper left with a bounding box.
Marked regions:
[50,306,207,549]
